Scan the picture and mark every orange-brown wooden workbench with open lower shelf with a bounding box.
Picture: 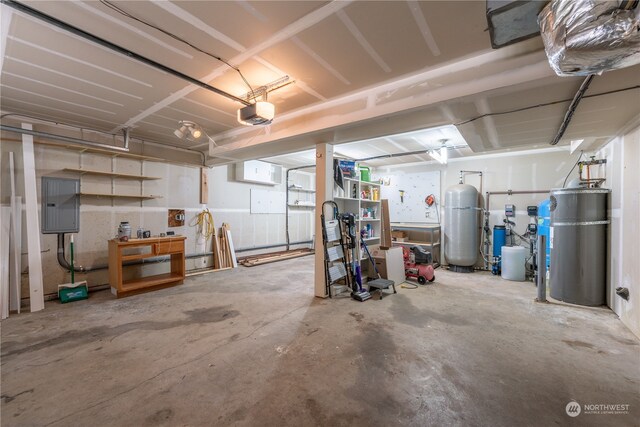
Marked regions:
[109,236,186,298]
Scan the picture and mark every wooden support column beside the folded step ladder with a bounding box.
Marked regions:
[314,143,333,298]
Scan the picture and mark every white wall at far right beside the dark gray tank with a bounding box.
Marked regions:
[598,127,640,337]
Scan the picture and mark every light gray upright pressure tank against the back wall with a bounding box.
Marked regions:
[444,184,479,273]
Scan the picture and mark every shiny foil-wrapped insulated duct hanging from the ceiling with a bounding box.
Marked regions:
[538,0,640,76]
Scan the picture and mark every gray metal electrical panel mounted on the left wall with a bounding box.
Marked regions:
[42,177,80,234]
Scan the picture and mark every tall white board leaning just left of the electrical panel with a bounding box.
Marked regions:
[22,123,44,312]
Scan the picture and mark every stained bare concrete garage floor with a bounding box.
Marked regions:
[1,257,640,426]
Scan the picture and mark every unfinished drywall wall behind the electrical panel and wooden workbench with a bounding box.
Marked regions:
[0,139,315,295]
